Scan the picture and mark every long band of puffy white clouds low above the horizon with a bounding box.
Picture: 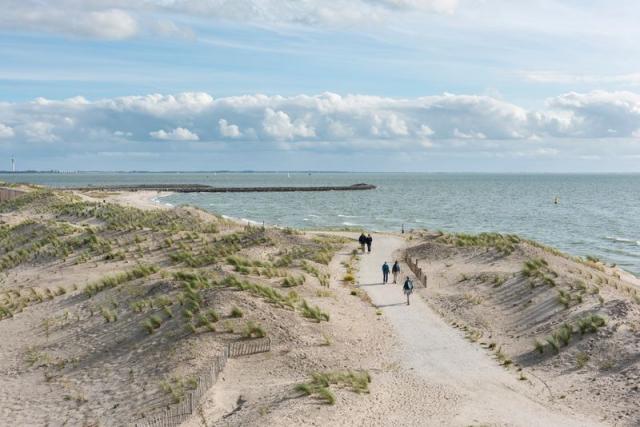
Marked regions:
[0,91,640,152]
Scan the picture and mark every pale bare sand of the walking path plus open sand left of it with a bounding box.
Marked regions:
[185,232,599,427]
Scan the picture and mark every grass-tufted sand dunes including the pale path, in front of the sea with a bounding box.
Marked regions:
[0,190,640,427]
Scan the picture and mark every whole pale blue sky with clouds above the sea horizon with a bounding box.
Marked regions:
[0,0,640,172]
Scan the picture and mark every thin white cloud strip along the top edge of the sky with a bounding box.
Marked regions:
[0,0,458,40]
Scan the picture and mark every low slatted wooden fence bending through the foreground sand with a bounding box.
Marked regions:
[134,337,271,427]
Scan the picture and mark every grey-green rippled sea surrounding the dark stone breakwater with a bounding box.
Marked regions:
[0,173,640,273]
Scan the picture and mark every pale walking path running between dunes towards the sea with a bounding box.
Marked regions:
[359,235,597,426]
